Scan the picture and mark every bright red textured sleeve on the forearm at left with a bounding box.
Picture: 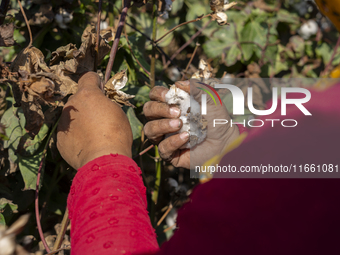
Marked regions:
[67,154,159,255]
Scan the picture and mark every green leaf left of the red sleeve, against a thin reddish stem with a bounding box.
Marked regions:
[18,150,43,190]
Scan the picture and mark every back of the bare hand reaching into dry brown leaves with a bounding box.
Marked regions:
[57,72,133,169]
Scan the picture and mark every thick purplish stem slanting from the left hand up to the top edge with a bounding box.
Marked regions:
[104,0,131,85]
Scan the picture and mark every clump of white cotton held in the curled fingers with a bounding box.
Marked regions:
[165,85,207,149]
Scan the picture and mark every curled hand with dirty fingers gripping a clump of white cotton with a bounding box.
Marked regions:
[144,78,239,169]
